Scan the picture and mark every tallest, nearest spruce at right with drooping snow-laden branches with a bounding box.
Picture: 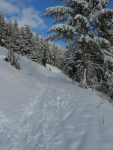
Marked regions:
[46,0,113,86]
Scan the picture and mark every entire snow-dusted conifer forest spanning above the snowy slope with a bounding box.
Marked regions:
[0,0,113,97]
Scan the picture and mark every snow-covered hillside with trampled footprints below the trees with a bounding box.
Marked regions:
[0,47,113,150]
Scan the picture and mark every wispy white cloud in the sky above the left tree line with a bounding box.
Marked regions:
[0,0,46,29]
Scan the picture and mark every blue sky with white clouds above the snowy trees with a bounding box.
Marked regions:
[0,0,113,45]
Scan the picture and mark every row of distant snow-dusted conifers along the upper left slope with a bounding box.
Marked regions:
[0,13,63,69]
